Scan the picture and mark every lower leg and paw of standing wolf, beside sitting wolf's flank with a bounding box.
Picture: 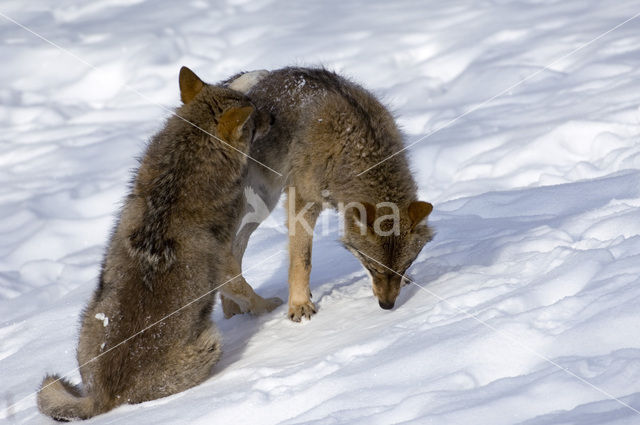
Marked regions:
[220,250,282,319]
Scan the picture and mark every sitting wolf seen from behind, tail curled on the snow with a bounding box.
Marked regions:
[38,68,279,420]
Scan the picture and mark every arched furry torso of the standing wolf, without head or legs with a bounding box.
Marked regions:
[236,67,417,203]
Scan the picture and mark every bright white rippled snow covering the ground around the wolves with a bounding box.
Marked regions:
[0,0,640,425]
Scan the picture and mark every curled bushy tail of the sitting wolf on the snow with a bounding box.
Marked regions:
[38,375,95,421]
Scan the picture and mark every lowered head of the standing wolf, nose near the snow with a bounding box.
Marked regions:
[342,201,433,310]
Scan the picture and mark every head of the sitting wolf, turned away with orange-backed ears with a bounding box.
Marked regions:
[179,66,273,149]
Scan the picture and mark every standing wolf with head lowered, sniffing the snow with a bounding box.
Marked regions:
[223,68,433,321]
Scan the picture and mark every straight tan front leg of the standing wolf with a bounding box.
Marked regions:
[287,188,321,322]
